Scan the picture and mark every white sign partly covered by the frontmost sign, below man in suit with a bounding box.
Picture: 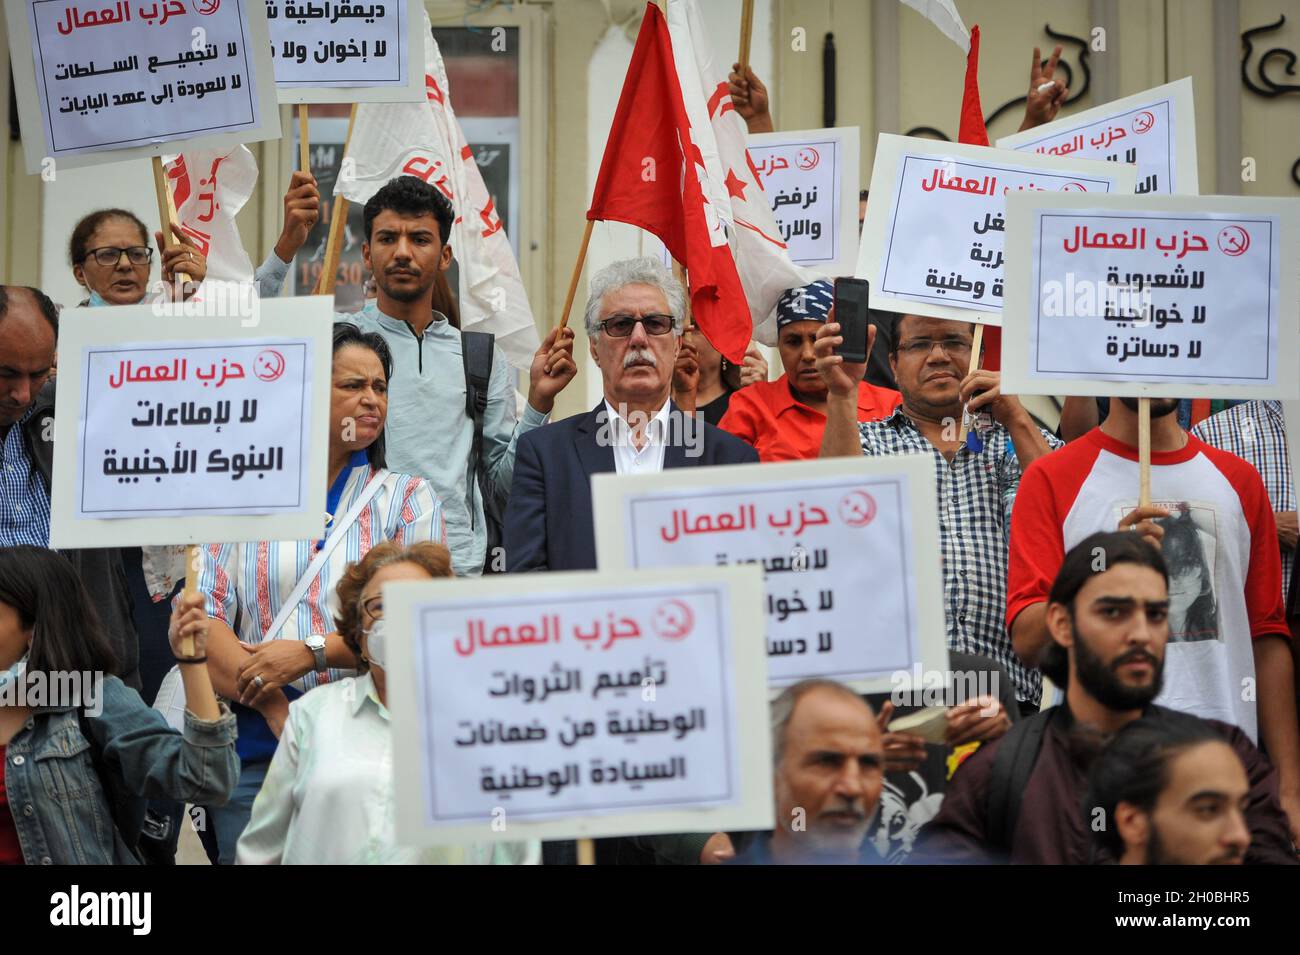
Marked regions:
[592,455,948,693]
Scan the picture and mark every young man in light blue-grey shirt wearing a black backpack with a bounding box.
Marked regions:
[339,175,577,577]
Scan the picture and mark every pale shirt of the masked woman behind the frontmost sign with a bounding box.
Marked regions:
[235,673,542,865]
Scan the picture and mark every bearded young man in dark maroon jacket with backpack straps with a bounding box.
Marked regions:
[913,531,1295,865]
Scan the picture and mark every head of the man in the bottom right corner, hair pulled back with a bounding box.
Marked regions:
[1083,716,1251,865]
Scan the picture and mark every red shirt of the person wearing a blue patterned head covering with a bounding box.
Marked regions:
[718,374,902,461]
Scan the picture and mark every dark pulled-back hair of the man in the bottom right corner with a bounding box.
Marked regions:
[1083,712,1226,860]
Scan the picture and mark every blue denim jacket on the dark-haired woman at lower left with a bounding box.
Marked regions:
[4,677,239,865]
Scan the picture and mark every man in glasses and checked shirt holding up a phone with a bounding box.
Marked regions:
[815,314,1061,709]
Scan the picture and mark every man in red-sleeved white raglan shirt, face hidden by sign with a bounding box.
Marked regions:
[1006,398,1300,842]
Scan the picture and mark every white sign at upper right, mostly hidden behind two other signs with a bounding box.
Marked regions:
[996,77,1200,196]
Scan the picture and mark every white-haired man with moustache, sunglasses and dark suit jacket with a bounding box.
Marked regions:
[504,257,758,572]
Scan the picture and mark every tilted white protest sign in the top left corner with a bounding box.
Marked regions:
[5,0,280,177]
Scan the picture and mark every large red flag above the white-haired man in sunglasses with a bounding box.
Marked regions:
[586,4,753,364]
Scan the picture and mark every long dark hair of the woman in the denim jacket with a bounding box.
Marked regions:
[0,544,117,674]
